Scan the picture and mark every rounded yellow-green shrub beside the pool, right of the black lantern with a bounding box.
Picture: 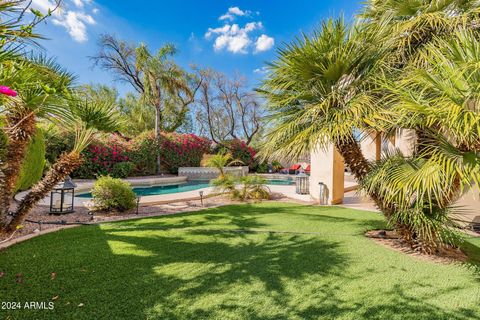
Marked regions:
[92,176,136,211]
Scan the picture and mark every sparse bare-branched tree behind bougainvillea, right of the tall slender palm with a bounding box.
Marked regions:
[195,69,265,145]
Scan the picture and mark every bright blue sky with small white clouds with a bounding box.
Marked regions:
[33,0,361,95]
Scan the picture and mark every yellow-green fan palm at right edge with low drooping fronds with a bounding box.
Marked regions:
[362,29,480,252]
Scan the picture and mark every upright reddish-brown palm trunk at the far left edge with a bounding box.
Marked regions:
[0,113,36,219]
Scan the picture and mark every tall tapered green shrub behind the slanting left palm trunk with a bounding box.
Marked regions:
[15,129,45,192]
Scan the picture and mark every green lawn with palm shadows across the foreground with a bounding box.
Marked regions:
[0,203,480,320]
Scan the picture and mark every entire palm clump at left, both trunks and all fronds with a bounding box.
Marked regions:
[0,1,120,233]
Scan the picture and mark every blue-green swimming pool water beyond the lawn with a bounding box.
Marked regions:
[77,179,293,198]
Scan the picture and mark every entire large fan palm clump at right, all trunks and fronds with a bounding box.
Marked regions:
[261,1,479,253]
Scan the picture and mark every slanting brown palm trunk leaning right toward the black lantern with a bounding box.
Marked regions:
[2,151,83,233]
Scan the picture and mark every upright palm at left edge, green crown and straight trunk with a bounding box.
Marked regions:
[0,57,74,221]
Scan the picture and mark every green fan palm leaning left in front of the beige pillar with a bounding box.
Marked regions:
[259,19,390,214]
